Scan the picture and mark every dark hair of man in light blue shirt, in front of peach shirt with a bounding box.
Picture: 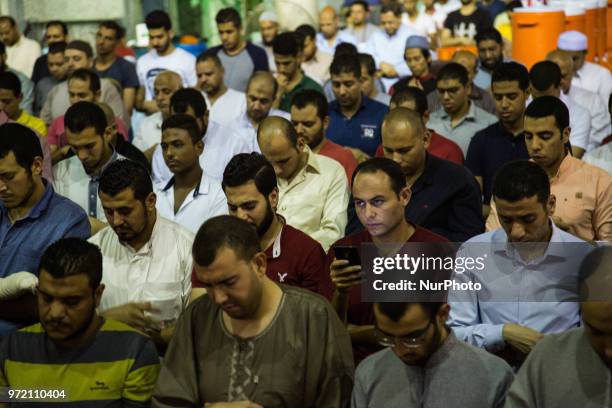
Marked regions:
[492,160,550,206]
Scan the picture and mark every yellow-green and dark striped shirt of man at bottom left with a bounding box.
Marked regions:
[0,319,160,408]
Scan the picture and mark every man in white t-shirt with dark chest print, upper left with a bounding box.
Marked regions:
[135,10,198,114]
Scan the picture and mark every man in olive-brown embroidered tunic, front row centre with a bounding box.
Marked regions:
[152,215,354,408]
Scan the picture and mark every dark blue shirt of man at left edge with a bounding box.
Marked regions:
[0,181,91,337]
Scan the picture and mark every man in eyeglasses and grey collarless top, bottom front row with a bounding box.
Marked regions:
[351,302,513,408]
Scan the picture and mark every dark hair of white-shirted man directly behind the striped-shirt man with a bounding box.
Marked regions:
[98,159,153,202]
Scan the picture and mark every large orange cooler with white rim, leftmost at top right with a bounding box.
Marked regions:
[511,7,565,69]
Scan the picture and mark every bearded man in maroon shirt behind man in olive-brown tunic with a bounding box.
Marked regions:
[191,153,325,299]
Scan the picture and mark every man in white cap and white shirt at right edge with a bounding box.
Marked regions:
[557,31,612,108]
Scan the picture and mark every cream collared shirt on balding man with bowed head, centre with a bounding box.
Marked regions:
[278,146,349,250]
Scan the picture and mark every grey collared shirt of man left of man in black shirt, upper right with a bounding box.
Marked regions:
[427,102,497,156]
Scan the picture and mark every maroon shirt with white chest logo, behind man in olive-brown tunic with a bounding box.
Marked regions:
[191,224,329,294]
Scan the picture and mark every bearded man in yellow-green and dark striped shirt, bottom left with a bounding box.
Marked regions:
[0,238,159,407]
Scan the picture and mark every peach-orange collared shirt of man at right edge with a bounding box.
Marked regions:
[487,155,612,241]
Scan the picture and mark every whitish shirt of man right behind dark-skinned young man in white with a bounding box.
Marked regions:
[151,121,253,185]
